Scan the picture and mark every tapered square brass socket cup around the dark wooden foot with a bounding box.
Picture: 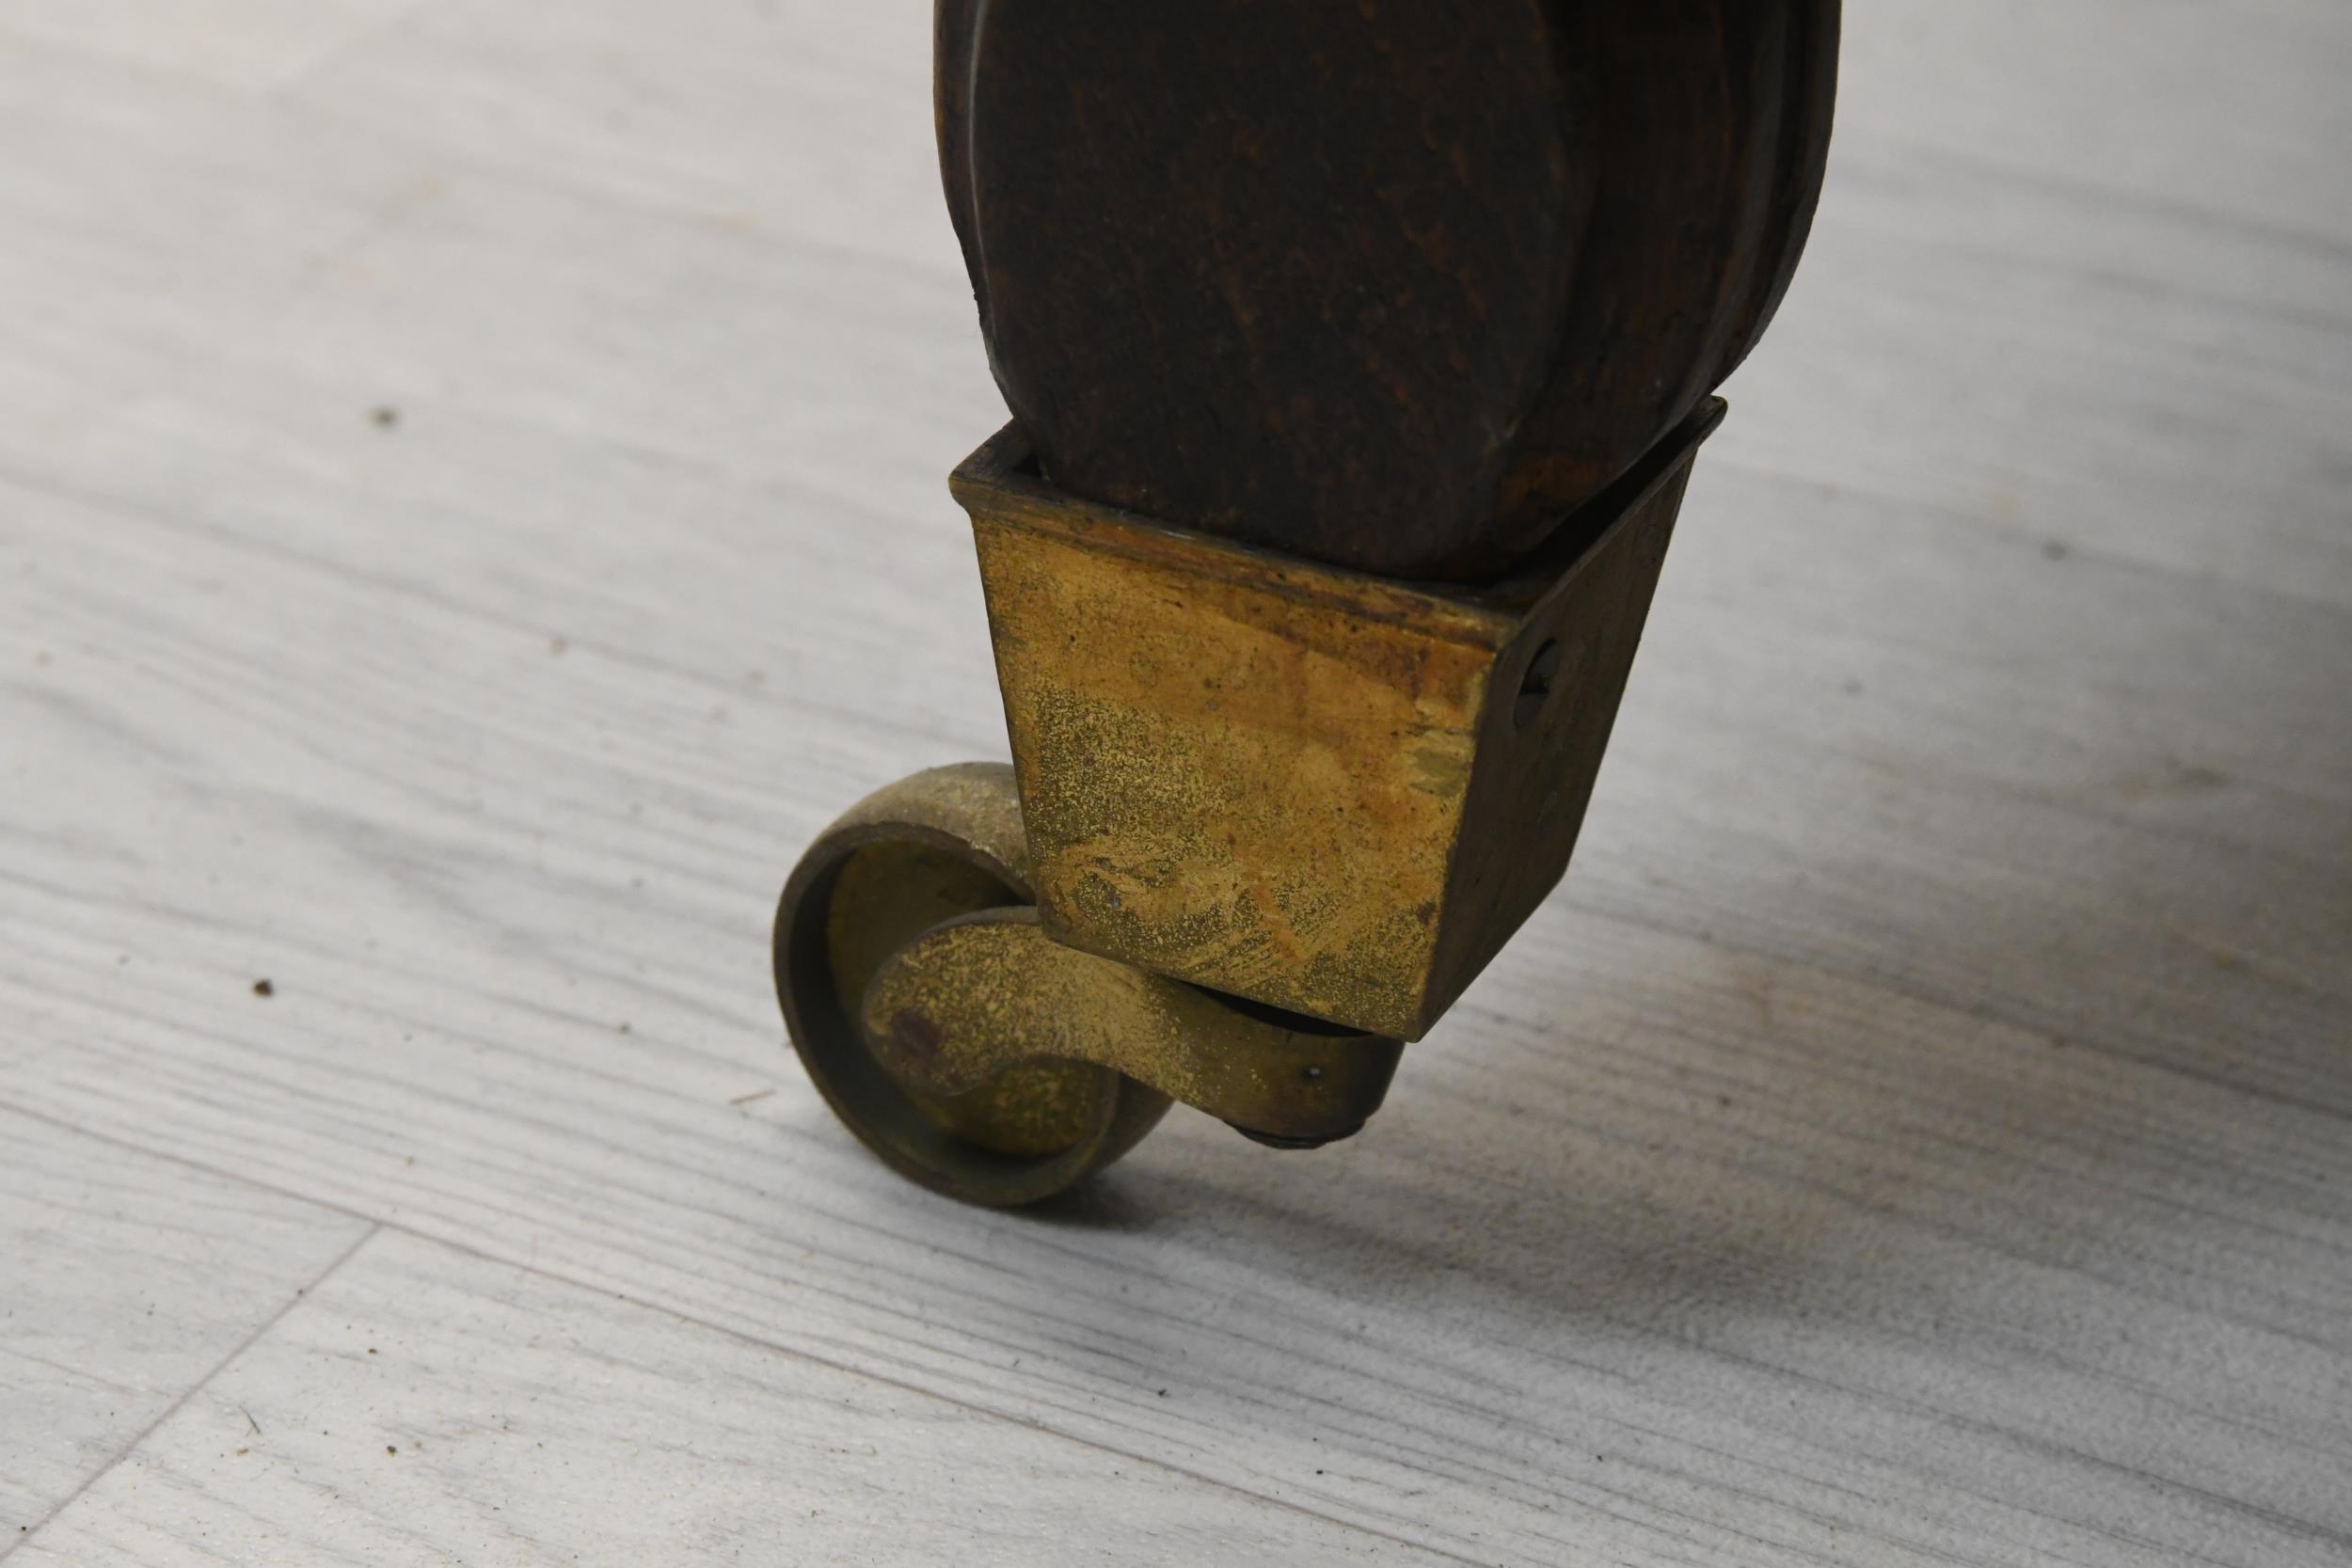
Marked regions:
[950,402,1722,1039]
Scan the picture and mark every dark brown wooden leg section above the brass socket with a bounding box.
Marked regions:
[936,0,1837,576]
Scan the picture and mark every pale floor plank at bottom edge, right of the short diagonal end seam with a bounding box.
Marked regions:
[19,1234,1444,1568]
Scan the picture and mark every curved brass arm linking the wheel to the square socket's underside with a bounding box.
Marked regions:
[864,908,1405,1145]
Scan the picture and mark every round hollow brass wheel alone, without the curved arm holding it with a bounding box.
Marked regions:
[776,762,1169,1206]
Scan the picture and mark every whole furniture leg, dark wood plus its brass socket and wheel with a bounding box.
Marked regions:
[776,0,1837,1204]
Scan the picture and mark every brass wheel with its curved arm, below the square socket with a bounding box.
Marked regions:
[776,762,1402,1206]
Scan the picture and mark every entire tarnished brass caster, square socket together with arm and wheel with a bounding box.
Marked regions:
[776,402,1722,1206]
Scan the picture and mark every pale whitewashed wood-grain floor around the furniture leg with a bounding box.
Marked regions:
[0,0,2352,1568]
